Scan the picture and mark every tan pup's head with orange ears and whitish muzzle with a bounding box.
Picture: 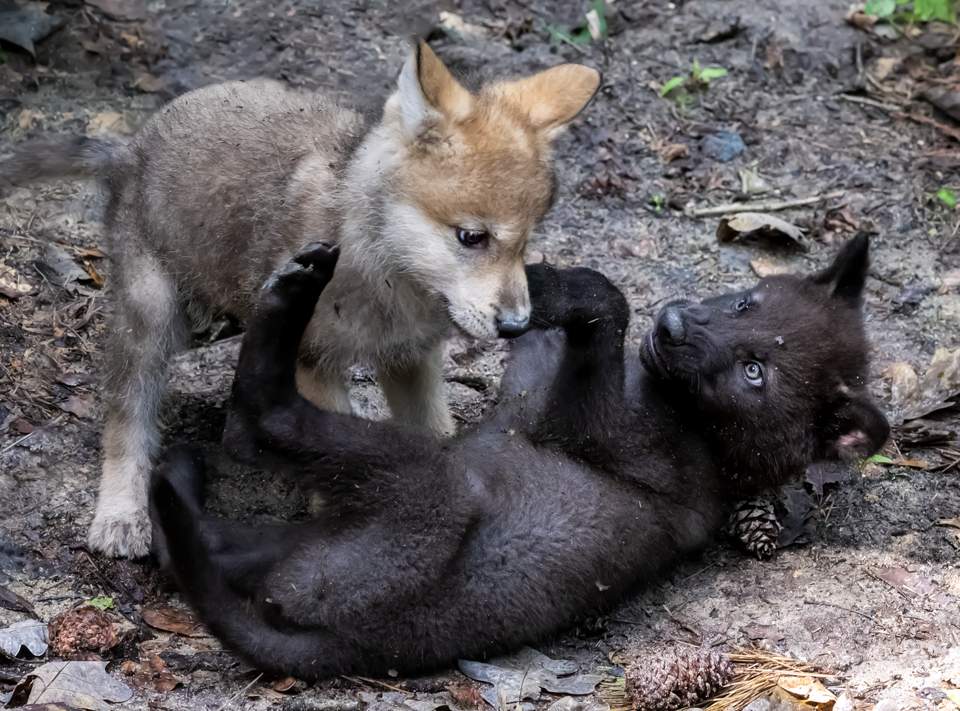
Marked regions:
[380,43,600,338]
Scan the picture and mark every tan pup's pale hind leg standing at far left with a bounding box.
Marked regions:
[87,253,188,558]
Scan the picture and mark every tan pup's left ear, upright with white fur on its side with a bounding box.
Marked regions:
[397,40,471,138]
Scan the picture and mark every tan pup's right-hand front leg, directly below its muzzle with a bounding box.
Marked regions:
[378,346,456,437]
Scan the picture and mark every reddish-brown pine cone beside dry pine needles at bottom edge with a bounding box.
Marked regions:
[624,652,733,711]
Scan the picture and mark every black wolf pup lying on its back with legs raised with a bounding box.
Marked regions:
[152,236,889,679]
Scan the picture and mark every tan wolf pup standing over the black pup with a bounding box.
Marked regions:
[0,43,600,556]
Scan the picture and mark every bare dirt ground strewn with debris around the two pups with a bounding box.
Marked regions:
[0,0,960,711]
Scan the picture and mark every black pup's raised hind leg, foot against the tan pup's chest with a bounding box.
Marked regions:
[223,245,439,506]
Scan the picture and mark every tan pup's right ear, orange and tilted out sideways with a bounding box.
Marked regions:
[503,64,600,140]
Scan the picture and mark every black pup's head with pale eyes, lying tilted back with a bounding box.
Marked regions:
[641,233,890,490]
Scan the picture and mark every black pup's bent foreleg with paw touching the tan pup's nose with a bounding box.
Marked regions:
[527,264,629,463]
